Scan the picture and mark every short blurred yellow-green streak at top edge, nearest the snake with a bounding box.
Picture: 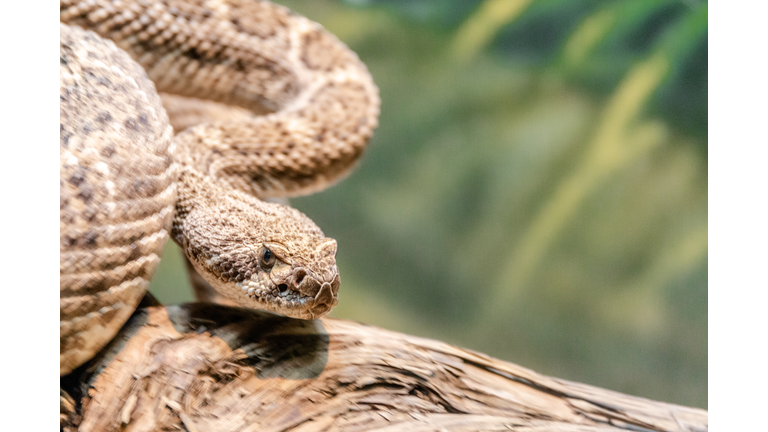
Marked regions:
[451,0,533,63]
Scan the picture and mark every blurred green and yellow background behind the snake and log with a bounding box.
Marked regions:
[151,0,707,408]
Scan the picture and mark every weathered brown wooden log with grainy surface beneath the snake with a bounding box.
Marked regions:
[61,299,708,432]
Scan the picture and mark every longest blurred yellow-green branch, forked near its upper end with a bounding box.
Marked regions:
[488,52,670,316]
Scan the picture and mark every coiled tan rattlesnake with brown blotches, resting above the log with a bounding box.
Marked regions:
[60,0,379,375]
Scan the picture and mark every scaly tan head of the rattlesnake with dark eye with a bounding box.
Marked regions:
[178,193,340,319]
